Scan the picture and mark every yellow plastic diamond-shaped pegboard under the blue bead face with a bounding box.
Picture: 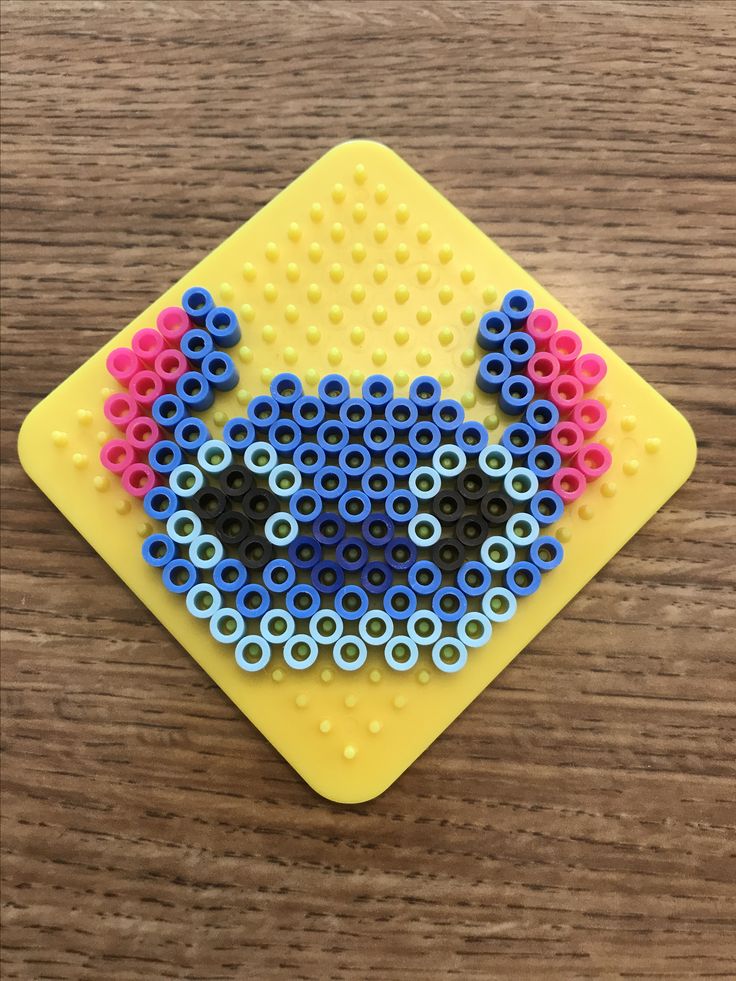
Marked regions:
[19,141,696,802]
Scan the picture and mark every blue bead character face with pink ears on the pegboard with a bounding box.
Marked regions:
[100,287,611,674]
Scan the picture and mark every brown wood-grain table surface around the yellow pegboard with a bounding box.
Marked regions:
[2,2,736,981]
